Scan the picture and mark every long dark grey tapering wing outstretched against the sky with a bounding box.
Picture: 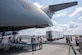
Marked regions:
[49,2,77,11]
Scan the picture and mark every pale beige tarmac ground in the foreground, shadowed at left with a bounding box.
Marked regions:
[0,39,82,55]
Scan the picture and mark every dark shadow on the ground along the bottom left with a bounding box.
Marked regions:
[0,48,40,55]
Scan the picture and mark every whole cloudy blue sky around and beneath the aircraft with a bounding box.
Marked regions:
[19,0,82,35]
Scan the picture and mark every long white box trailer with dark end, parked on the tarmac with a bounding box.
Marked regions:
[46,31,64,41]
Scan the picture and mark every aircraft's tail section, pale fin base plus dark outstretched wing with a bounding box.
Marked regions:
[42,1,77,18]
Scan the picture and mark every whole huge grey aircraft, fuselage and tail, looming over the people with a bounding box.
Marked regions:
[0,0,77,34]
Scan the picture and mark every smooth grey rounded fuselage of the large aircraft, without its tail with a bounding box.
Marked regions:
[0,0,52,28]
